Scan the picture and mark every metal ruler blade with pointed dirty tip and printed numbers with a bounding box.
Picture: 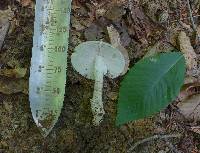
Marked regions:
[29,0,71,136]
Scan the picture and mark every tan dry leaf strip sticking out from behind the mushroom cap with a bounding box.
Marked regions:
[107,25,130,75]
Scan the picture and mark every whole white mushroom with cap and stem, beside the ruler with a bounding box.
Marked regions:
[71,41,125,125]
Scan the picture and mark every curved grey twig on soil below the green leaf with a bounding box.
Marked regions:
[127,134,181,153]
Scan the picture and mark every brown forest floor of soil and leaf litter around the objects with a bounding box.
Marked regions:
[0,0,200,153]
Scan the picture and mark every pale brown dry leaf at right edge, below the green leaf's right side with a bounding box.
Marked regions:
[177,94,200,121]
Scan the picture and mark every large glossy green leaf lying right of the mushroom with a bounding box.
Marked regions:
[116,52,185,125]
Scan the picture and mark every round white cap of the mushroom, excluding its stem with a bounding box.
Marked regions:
[71,41,126,79]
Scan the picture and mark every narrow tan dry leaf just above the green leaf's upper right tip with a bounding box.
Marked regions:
[178,31,197,70]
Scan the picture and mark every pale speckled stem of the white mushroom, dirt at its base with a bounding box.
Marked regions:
[91,56,107,125]
